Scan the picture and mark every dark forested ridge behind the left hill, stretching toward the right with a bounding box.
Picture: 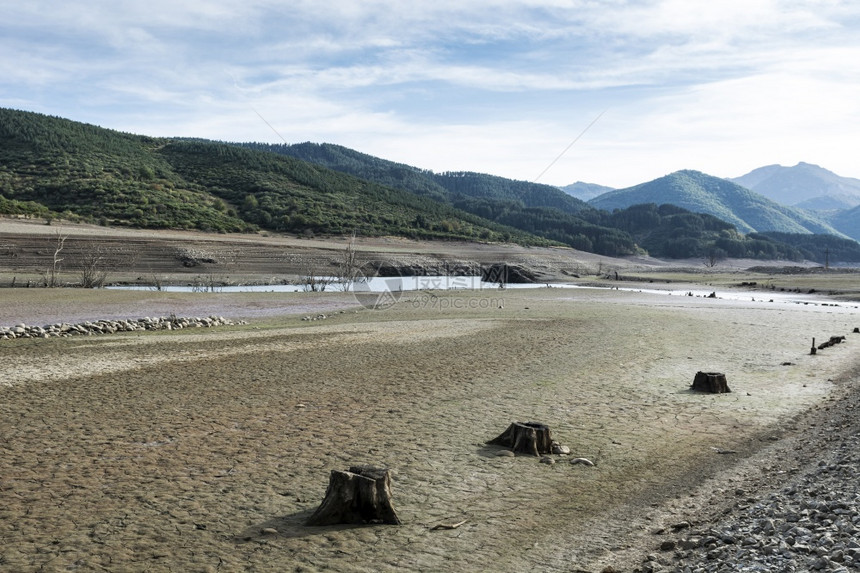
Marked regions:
[243,143,860,260]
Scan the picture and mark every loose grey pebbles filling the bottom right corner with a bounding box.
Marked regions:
[634,406,860,573]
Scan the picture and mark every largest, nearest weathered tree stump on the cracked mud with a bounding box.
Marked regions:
[306,466,401,525]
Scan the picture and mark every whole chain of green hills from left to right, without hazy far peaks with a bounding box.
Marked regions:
[5,109,860,261]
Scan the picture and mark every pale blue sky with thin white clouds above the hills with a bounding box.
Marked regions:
[0,0,860,188]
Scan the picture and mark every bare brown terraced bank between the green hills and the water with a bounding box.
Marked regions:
[0,217,828,290]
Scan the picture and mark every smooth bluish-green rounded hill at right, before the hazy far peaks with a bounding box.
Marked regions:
[589,171,839,235]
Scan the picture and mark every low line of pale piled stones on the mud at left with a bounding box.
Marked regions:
[0,316,242,340]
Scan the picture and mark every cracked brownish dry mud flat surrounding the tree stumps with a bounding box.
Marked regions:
[0,288,860,572]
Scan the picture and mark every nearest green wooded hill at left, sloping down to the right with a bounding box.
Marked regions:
[0,109,548,245]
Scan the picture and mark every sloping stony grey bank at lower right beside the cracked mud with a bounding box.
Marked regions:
[634,374,860,573]
